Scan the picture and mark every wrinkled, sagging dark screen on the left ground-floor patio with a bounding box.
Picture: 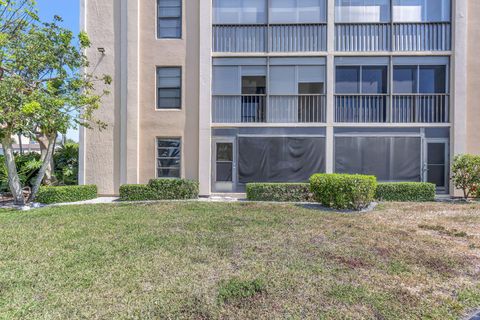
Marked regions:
[238,137,325,183]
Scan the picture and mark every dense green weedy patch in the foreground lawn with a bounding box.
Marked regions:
[218,278,266,303]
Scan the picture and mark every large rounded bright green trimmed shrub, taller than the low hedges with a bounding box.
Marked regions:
[310,174,377,210]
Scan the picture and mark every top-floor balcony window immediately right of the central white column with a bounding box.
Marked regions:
[335,0,390,23]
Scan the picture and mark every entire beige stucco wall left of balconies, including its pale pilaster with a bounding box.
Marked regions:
[80,0,199,195]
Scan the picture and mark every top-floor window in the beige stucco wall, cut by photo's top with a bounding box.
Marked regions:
[157,0,182,39]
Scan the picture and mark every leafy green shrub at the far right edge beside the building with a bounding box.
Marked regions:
[451,154,480,199]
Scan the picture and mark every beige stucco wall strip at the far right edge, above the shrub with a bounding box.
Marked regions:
[467,0,480,154]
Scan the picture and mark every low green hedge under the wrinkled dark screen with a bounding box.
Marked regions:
[247,183,313,202]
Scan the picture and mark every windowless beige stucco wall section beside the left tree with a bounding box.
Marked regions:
[80,1,120,195]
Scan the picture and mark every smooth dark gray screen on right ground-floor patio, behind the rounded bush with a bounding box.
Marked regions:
[335,137,421,181]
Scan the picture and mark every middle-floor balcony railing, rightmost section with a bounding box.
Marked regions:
[392,94,450,123]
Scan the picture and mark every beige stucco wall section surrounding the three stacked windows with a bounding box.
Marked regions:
[139,0,199,183]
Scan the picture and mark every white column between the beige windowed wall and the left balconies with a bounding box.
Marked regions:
[198,0,212,196]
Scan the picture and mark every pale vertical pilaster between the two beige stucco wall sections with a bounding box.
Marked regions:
[120,0,140,184]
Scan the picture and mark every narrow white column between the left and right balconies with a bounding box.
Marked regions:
[325,0,335,173]
